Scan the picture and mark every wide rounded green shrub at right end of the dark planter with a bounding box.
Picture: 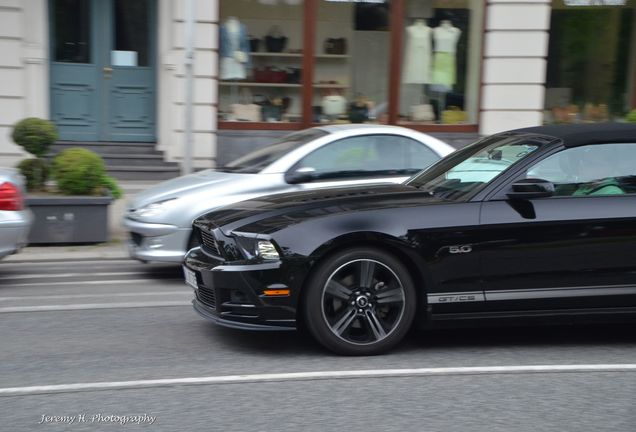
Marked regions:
[51,147,106,195]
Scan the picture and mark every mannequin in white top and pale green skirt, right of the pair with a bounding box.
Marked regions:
[432,20,462,91]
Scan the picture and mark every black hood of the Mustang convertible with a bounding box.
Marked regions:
[196,184,443,234]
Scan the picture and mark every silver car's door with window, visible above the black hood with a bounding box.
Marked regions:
[285,134,441,189]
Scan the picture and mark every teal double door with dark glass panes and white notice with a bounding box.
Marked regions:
[49,0,157,142]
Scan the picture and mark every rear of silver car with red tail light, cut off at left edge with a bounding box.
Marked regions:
[0,168,33,258]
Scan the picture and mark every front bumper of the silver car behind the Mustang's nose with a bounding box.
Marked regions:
[123,218,192,263]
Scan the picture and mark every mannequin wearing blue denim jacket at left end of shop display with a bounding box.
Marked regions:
[219,17,250,80]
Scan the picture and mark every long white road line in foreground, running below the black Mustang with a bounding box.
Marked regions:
[0,364,636,396]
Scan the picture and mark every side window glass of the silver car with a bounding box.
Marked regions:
[295,135,439,179]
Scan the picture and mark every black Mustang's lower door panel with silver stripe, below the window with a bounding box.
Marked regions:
[479,195,636,309]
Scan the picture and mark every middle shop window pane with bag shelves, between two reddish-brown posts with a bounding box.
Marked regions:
[312,0,391,123]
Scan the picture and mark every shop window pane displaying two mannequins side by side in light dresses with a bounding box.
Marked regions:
[399,0,483,125]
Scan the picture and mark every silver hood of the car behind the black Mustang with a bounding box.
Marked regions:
[128,169,255,209]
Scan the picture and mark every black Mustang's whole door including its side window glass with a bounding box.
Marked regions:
[479,143,636,311]
